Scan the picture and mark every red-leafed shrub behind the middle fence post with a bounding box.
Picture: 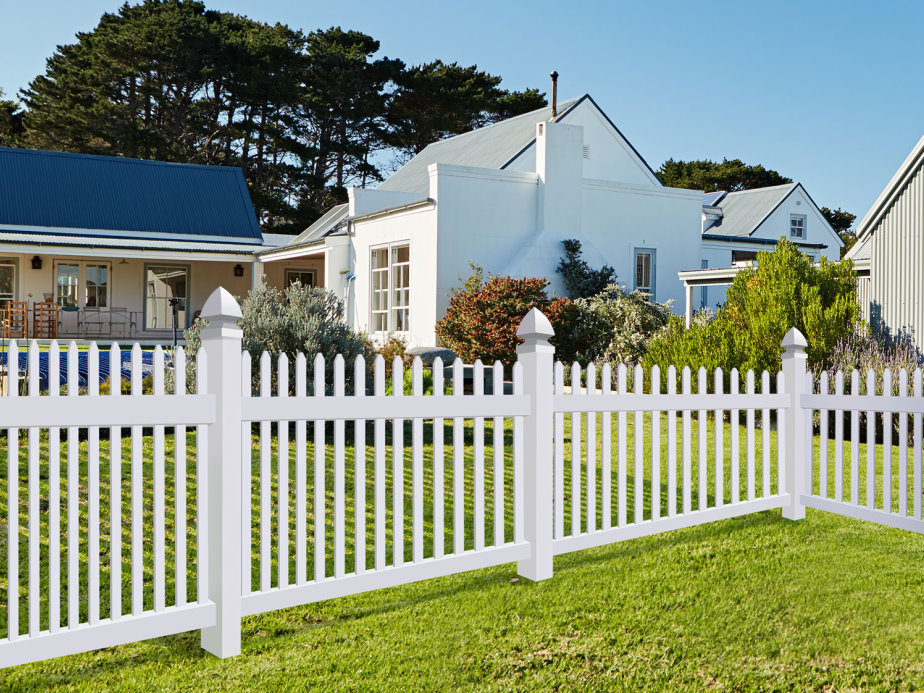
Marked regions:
[436,265,577,365]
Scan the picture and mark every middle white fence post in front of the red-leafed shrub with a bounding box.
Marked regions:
[517,308,555,581]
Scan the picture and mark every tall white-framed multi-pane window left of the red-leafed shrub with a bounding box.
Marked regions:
[369,242,411,332]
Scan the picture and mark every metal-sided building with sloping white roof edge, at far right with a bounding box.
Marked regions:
[846,132,924,351]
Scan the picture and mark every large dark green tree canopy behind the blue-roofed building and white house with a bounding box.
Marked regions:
[7,0,545,231]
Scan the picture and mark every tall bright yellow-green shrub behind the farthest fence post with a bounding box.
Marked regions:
[645,239,860,384]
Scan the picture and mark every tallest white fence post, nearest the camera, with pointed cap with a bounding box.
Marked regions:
[199,287,243,659]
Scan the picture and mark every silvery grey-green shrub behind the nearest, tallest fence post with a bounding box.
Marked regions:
[184,278,371,393]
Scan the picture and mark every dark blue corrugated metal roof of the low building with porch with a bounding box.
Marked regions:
[0,147,261,244]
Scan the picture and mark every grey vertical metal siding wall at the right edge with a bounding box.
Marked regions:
[861,162,924,350]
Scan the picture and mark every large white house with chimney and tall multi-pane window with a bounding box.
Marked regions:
[260,95,702,346]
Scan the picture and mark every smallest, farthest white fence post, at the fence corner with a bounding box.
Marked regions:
[783,327,811,520]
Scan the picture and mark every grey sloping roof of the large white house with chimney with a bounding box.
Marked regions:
[378,97,584,195]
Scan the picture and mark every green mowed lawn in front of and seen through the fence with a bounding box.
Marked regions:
[0,414,924,691]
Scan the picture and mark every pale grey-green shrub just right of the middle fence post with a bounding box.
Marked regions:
[573,284,671,364]
